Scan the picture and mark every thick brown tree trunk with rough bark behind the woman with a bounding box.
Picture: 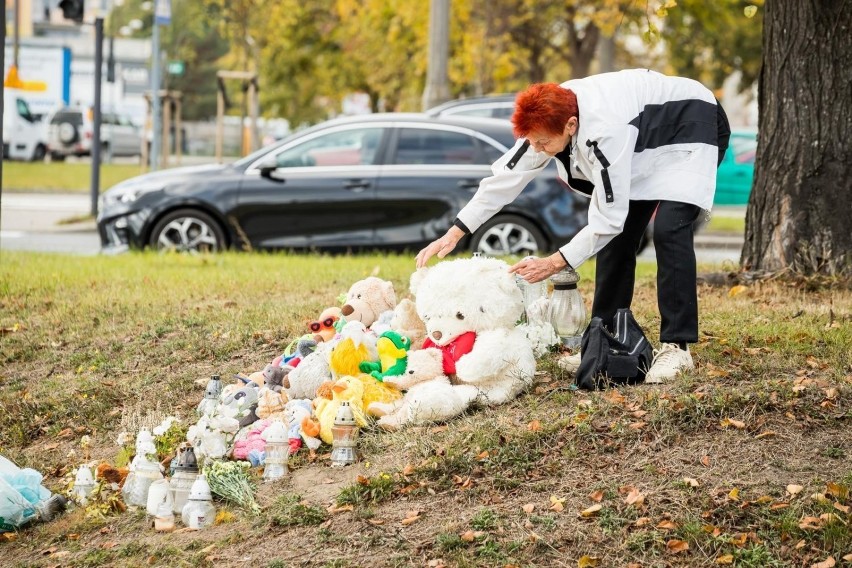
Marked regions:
[742,0,852,276]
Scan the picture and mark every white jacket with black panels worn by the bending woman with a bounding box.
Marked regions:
[456,69,718,268]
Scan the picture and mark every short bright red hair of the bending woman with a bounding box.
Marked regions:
[512,83,579,137]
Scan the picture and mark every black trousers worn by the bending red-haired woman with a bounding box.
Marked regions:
[592,104,731,343]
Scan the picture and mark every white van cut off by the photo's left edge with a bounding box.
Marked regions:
[3,87,47,161]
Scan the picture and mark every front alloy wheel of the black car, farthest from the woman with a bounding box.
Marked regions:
[151,209,225,253]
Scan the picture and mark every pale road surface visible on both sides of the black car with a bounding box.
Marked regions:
[0,193,742,263]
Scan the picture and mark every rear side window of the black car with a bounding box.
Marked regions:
[392,128,491,165]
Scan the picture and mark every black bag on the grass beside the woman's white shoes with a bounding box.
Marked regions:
[575,308,654,390]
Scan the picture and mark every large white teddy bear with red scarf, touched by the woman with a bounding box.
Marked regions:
[411,257,535,405]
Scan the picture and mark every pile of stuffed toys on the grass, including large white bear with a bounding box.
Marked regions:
[188,258,536,464]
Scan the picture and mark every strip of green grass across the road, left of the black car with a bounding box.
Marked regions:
[3,161,145,193]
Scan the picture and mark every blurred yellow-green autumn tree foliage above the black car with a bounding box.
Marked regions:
[107,0,763,126]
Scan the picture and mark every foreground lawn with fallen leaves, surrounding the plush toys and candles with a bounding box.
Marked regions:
[0,251,852,567]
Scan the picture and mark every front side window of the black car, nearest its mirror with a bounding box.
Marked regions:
[275,128,383,168]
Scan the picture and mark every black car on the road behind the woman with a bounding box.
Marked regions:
[98,113,588,256]
